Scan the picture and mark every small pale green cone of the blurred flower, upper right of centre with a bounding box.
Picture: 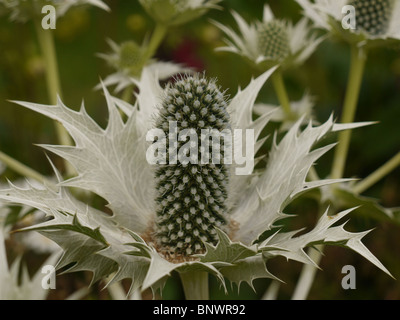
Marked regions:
[258,20,290,61]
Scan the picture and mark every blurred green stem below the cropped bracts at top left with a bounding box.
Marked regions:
[35,20,75,175]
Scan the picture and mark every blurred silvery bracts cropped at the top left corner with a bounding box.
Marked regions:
[0,0,110,22]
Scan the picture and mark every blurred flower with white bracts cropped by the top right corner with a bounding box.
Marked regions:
[296,0,400,46]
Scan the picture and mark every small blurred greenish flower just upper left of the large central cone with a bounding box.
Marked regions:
[96,39,190,92]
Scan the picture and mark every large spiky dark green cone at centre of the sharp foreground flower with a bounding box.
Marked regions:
[156,75,230,259]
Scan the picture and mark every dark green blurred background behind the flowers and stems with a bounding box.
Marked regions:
[0,0,400,299]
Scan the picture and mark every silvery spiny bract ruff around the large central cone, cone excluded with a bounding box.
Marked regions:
[0,68,389,296]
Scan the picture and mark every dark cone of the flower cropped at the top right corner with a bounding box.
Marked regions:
[351,0,394,36]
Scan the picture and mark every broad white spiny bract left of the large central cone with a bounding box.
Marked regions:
[11,89,153,231]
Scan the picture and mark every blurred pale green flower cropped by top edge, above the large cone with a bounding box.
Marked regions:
[139,0,221,26]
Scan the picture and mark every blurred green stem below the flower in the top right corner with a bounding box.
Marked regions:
[331,45,367,179]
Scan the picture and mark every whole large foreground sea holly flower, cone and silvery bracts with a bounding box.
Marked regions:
[0,67,389,298]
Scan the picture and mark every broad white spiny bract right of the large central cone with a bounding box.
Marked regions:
[233,117,368,244]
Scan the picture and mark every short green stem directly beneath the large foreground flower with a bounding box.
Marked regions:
[180,271,209,300]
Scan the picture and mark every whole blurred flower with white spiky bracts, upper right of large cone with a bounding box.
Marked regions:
[214,5,323,67]
